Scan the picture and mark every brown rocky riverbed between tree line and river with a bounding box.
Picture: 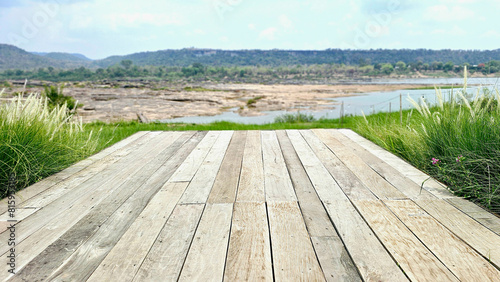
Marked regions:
[1,81,434,122]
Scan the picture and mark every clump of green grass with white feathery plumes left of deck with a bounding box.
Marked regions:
[0,91,98,197]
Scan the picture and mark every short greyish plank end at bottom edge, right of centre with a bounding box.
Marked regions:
[311,236,362,282]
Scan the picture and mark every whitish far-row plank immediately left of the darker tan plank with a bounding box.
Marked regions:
[180,131,233,204]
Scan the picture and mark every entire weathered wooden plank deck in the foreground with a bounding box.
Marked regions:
[0,129,500,281]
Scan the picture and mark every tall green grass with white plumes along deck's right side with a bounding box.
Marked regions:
[354,82,500,213]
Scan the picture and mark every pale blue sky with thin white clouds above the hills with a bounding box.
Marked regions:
[0,0,500,59]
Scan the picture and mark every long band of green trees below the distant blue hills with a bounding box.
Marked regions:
[0,60,500,83]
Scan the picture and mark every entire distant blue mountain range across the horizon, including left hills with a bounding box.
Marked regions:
[0,44,500,70]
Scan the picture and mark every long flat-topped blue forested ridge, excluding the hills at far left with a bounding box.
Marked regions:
[94,49,500,67]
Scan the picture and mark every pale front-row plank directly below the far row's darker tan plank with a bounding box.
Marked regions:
[179,204,233,281]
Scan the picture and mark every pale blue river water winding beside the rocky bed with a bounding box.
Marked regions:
[161,78,500,124]
